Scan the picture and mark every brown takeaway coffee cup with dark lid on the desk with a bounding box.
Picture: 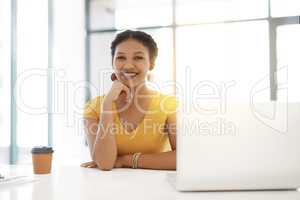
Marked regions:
[31,146,53,174]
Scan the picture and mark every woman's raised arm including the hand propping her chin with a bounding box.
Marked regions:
[85,76,131,170]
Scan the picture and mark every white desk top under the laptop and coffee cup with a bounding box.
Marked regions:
[0,165,300,200]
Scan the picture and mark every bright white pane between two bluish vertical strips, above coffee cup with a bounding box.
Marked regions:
[16,0,48,152]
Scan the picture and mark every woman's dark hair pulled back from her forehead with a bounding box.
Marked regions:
[110,30,158,67]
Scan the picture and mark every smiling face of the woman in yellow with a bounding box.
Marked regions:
[113,39,150,88]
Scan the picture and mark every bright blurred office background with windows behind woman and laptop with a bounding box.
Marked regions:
[0,0,300,164]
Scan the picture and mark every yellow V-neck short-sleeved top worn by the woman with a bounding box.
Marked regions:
[83,92,177,155]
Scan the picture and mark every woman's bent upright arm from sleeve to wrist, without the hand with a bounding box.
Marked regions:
[85,100,117,170]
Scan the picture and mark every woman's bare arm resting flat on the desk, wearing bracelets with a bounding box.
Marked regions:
[122,113,176,170]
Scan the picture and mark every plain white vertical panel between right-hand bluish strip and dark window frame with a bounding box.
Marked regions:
[50,0,89,165]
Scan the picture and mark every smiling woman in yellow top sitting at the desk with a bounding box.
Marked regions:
[81,30,177,170]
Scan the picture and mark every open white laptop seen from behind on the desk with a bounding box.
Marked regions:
[168,102,300,191]
